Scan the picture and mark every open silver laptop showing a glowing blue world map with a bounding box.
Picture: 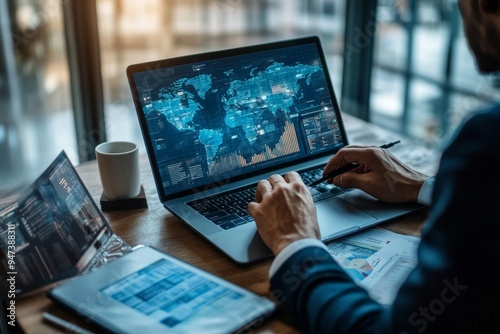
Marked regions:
[126,36,422,263]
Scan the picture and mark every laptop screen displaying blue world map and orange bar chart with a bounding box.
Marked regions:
[127,37,347,198]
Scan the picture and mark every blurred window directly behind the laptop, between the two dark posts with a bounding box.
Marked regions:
[97,0,345,151]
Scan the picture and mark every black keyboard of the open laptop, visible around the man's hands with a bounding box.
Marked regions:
[186,167,348,230]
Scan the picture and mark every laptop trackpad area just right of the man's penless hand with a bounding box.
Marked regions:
[316,199,377,241]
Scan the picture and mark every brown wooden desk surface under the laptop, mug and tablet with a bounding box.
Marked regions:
[6,115,438,333]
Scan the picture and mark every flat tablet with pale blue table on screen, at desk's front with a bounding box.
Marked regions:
[48,247,276,333]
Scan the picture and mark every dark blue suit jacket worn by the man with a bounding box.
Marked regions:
[271,105,500,333]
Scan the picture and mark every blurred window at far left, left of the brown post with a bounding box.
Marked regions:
[0,0,74,194]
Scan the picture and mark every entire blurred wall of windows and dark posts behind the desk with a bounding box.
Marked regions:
[0,0,500,194]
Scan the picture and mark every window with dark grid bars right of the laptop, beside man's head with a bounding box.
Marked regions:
[370,0,500,147]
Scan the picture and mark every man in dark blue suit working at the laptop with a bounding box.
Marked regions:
[248,0,500,333]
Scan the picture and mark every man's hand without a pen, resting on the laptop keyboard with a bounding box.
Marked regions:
[248,172,320,255]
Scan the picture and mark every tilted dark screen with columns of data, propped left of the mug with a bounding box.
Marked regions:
[0,151,110,293]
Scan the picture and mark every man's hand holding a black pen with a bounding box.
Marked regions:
[323,145,428,203]
